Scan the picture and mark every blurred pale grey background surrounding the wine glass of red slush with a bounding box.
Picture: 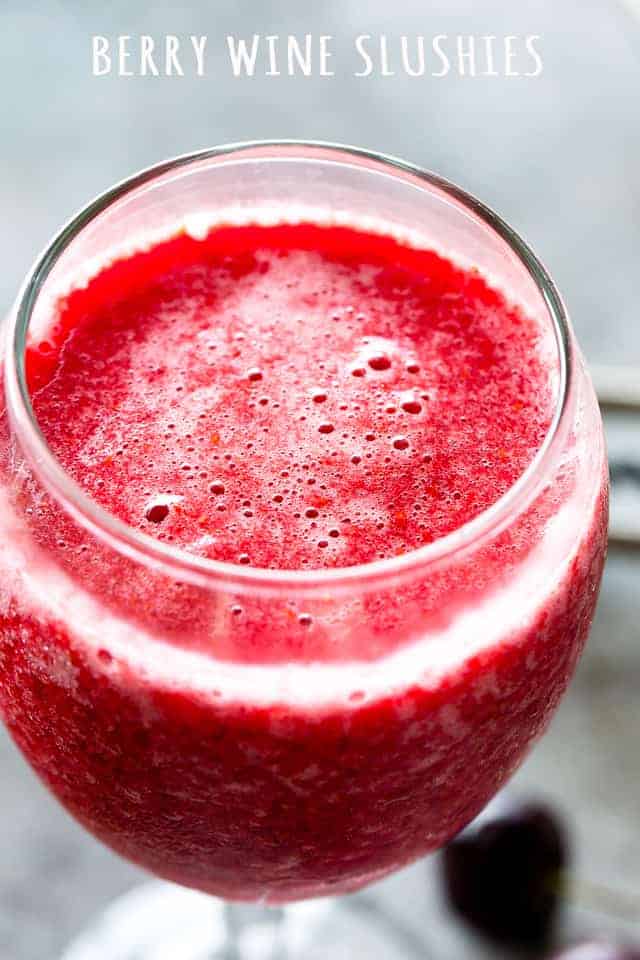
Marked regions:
[0,0,640,960]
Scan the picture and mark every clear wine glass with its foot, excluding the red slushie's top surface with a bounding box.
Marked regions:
[0,142,607,960]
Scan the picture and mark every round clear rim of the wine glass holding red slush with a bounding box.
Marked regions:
[5,139,574,593]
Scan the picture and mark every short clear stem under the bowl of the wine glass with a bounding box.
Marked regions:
[222,903,286,960]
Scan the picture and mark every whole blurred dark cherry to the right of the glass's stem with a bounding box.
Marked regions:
[441,799,568,944]
